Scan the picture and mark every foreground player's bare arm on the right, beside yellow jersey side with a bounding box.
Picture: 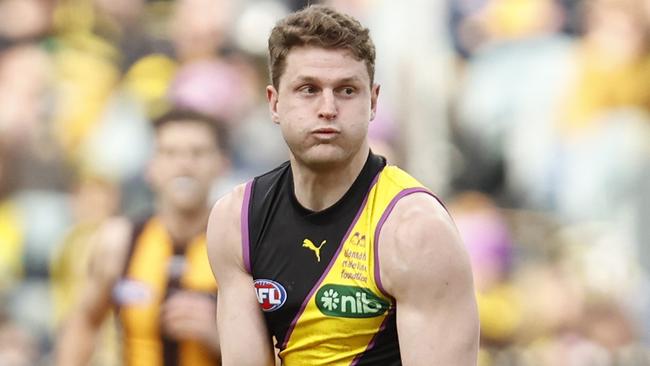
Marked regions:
[380,195,479,365]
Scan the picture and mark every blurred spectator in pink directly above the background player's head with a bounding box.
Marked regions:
[169,0,259,124]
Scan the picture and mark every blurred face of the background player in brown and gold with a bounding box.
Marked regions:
[150,122,223,211]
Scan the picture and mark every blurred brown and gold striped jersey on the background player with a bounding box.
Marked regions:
[113,217,219,366]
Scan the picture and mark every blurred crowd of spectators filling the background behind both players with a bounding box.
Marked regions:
[0,0,650,366]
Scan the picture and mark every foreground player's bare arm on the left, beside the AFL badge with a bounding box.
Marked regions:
[208,190,273,365]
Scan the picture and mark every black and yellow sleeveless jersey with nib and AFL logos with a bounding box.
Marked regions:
[242,153,430,366]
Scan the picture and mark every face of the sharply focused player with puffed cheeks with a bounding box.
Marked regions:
[267,46,379,169]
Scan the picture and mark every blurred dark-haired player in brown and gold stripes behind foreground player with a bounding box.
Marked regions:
[56,110,226,366]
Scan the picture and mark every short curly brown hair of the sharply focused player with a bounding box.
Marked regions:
[269,5,375,88]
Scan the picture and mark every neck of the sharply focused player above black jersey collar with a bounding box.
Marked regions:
[291,148,369,211]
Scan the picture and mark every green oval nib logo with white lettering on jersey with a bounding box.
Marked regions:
[316,285,389,318]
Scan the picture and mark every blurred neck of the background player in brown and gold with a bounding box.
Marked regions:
[158,205,209,244]
